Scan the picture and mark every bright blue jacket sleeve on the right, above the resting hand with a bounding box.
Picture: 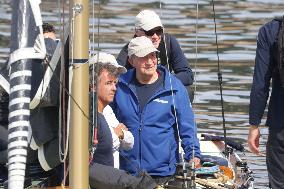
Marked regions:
[175,80,200,161]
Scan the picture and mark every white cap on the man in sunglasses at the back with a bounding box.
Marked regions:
[135,10,163,31]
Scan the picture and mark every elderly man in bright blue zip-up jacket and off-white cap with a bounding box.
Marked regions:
[113,36,200,184]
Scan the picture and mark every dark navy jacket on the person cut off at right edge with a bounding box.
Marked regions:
[249,20,284,133]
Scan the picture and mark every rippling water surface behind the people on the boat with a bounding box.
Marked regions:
[0,0,284,188]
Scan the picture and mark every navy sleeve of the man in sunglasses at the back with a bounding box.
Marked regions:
[169,35,193,86]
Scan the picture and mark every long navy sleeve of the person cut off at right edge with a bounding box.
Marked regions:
[249,22,278,125]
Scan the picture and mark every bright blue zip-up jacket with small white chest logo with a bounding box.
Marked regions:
[113,66,200,176]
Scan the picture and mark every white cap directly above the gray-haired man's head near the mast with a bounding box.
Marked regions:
[89,52,127,73]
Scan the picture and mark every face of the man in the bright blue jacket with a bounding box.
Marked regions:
[130,52,157,77]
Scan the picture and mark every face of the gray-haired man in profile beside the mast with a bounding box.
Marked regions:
[97,70,117,106]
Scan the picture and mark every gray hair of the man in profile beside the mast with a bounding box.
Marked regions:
[89,62,119,85]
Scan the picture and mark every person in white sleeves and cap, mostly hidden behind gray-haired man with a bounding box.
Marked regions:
[89,52,134,169]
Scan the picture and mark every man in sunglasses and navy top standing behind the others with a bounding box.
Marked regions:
[117,10,193,98]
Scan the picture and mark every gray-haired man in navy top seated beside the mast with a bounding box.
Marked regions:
[89,54,156,189]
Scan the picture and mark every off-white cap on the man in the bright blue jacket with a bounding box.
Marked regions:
[128,36,158,57]
